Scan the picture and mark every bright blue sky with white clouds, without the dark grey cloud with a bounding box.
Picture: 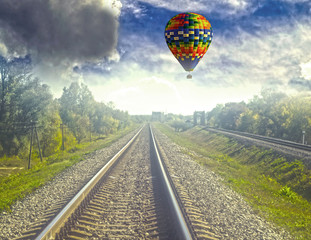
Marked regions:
[0,0,311,114]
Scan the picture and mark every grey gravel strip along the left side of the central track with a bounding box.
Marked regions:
[0,131,136,240]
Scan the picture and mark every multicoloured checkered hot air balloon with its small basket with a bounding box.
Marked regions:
[165,12,213,78]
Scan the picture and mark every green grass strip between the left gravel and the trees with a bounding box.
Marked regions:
[0,125,137,211]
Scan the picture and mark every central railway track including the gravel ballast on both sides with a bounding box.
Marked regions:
[0,124,290,240]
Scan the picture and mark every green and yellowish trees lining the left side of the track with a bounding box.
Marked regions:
[0,56,131,157]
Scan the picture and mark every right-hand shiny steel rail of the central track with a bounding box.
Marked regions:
[149,126,194,240]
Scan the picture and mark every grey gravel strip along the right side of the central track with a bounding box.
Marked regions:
[155,126,291,240]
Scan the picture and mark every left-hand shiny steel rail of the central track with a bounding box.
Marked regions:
[36,127,143,240]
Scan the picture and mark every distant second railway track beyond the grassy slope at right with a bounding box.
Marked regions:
[204,127,311,152]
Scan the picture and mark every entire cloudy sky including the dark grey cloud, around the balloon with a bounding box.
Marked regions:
[0,0,311,115]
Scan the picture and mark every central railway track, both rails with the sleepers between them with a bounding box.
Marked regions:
[36,127,200,240]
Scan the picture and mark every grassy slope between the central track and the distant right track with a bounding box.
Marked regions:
[156,124,311,239]
